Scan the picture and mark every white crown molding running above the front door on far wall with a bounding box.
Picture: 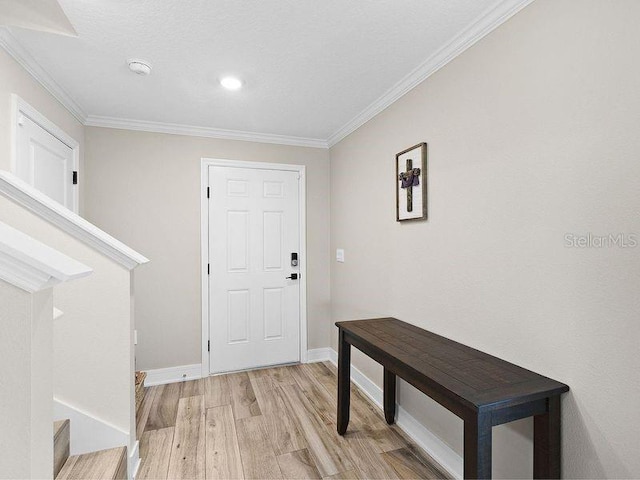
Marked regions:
[85,115,328,148]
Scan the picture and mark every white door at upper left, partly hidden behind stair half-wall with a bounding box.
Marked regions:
[16,114,77,210]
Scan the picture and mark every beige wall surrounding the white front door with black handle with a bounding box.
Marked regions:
[85,127,329,369]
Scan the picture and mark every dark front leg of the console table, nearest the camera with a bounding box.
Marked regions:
[464,412,491,479]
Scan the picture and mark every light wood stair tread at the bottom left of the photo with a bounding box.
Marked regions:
[56,447,127,480]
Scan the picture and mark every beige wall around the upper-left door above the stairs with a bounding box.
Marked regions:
[0,48,84,213]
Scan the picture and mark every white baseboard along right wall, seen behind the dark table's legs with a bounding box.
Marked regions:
[327,349,463,478]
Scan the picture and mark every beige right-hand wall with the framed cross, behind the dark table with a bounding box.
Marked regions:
[331,0,640,478]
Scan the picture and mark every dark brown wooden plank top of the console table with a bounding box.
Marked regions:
[336,318,569,409]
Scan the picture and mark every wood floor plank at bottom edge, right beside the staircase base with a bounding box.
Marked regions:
[136,427,175,480]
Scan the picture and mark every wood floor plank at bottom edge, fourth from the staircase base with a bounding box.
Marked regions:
[236,416,282,479]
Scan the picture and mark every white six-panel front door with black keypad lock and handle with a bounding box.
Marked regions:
[209,166,300,373]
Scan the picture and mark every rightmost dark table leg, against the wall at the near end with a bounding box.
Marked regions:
[533,395,561,478]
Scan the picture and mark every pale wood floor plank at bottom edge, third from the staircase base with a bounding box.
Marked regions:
[205,405,244,480]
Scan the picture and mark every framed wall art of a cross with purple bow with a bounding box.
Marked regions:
[396,143,427,222]
